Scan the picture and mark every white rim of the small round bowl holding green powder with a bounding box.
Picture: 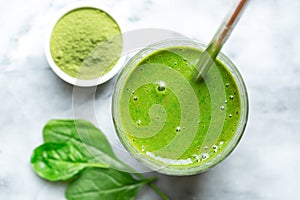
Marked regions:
[45,1,125,87]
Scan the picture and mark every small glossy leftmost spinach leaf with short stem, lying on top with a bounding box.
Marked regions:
[31,143,108,181]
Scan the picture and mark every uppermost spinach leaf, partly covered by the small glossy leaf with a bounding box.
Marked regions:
[43,120,128,170]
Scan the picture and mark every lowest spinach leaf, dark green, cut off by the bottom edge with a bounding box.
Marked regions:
[65,168,152,200]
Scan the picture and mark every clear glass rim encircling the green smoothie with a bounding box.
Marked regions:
[112,39,249,176]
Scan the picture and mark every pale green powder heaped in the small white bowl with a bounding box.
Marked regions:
[50,8,122,80]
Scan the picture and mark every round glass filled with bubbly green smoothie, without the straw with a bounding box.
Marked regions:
[112,39,248,175]
